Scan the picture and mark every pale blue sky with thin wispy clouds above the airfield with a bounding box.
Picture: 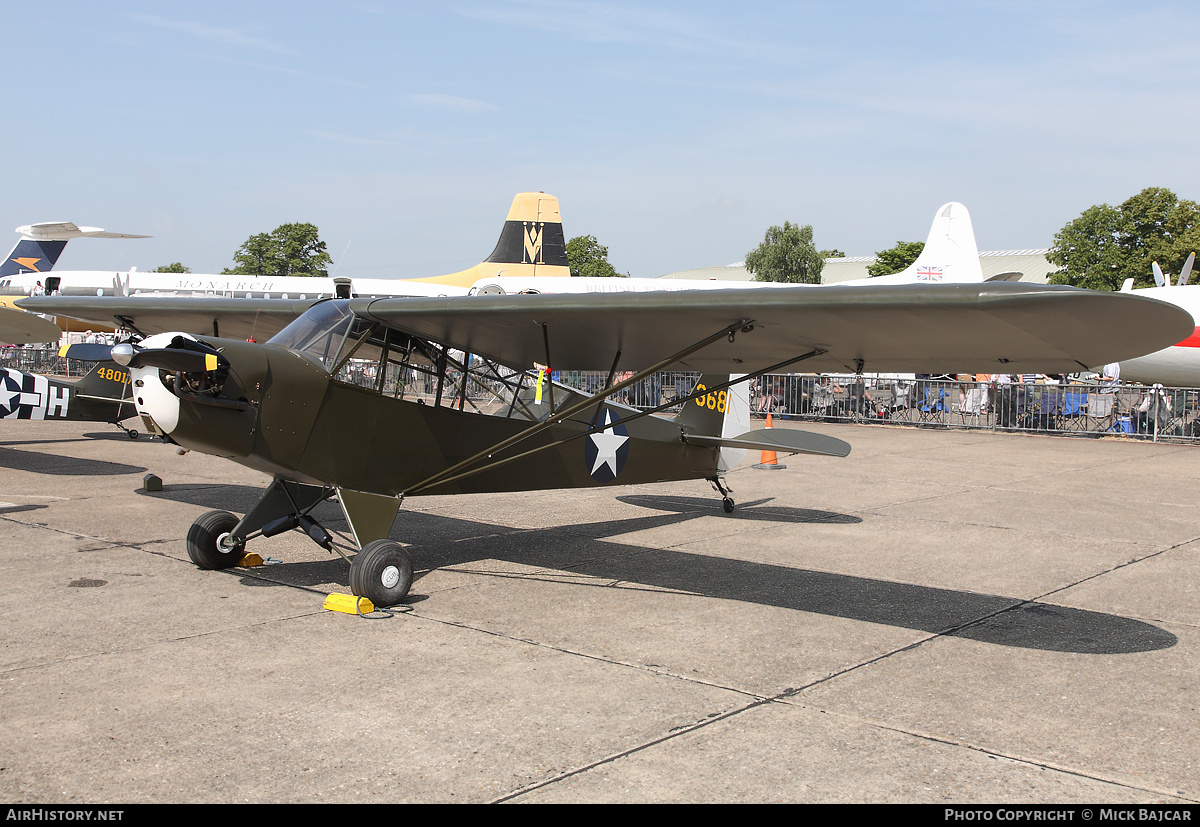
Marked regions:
[0,0,1200,277]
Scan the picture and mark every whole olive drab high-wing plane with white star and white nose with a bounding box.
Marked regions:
[11,283,1194,606]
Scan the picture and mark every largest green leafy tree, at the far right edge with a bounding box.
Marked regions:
[1046,187,1200,290]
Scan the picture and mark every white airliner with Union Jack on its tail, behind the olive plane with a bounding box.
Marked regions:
[470,202,1021,295]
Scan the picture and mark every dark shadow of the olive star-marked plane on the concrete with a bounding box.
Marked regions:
[148,485,1177,654]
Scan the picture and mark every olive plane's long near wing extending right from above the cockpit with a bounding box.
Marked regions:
[350,282,1194,373]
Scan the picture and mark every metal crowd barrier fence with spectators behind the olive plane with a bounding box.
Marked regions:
[7,346,1200,442]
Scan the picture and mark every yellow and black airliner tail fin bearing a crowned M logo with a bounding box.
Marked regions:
[412,192,571,287]
